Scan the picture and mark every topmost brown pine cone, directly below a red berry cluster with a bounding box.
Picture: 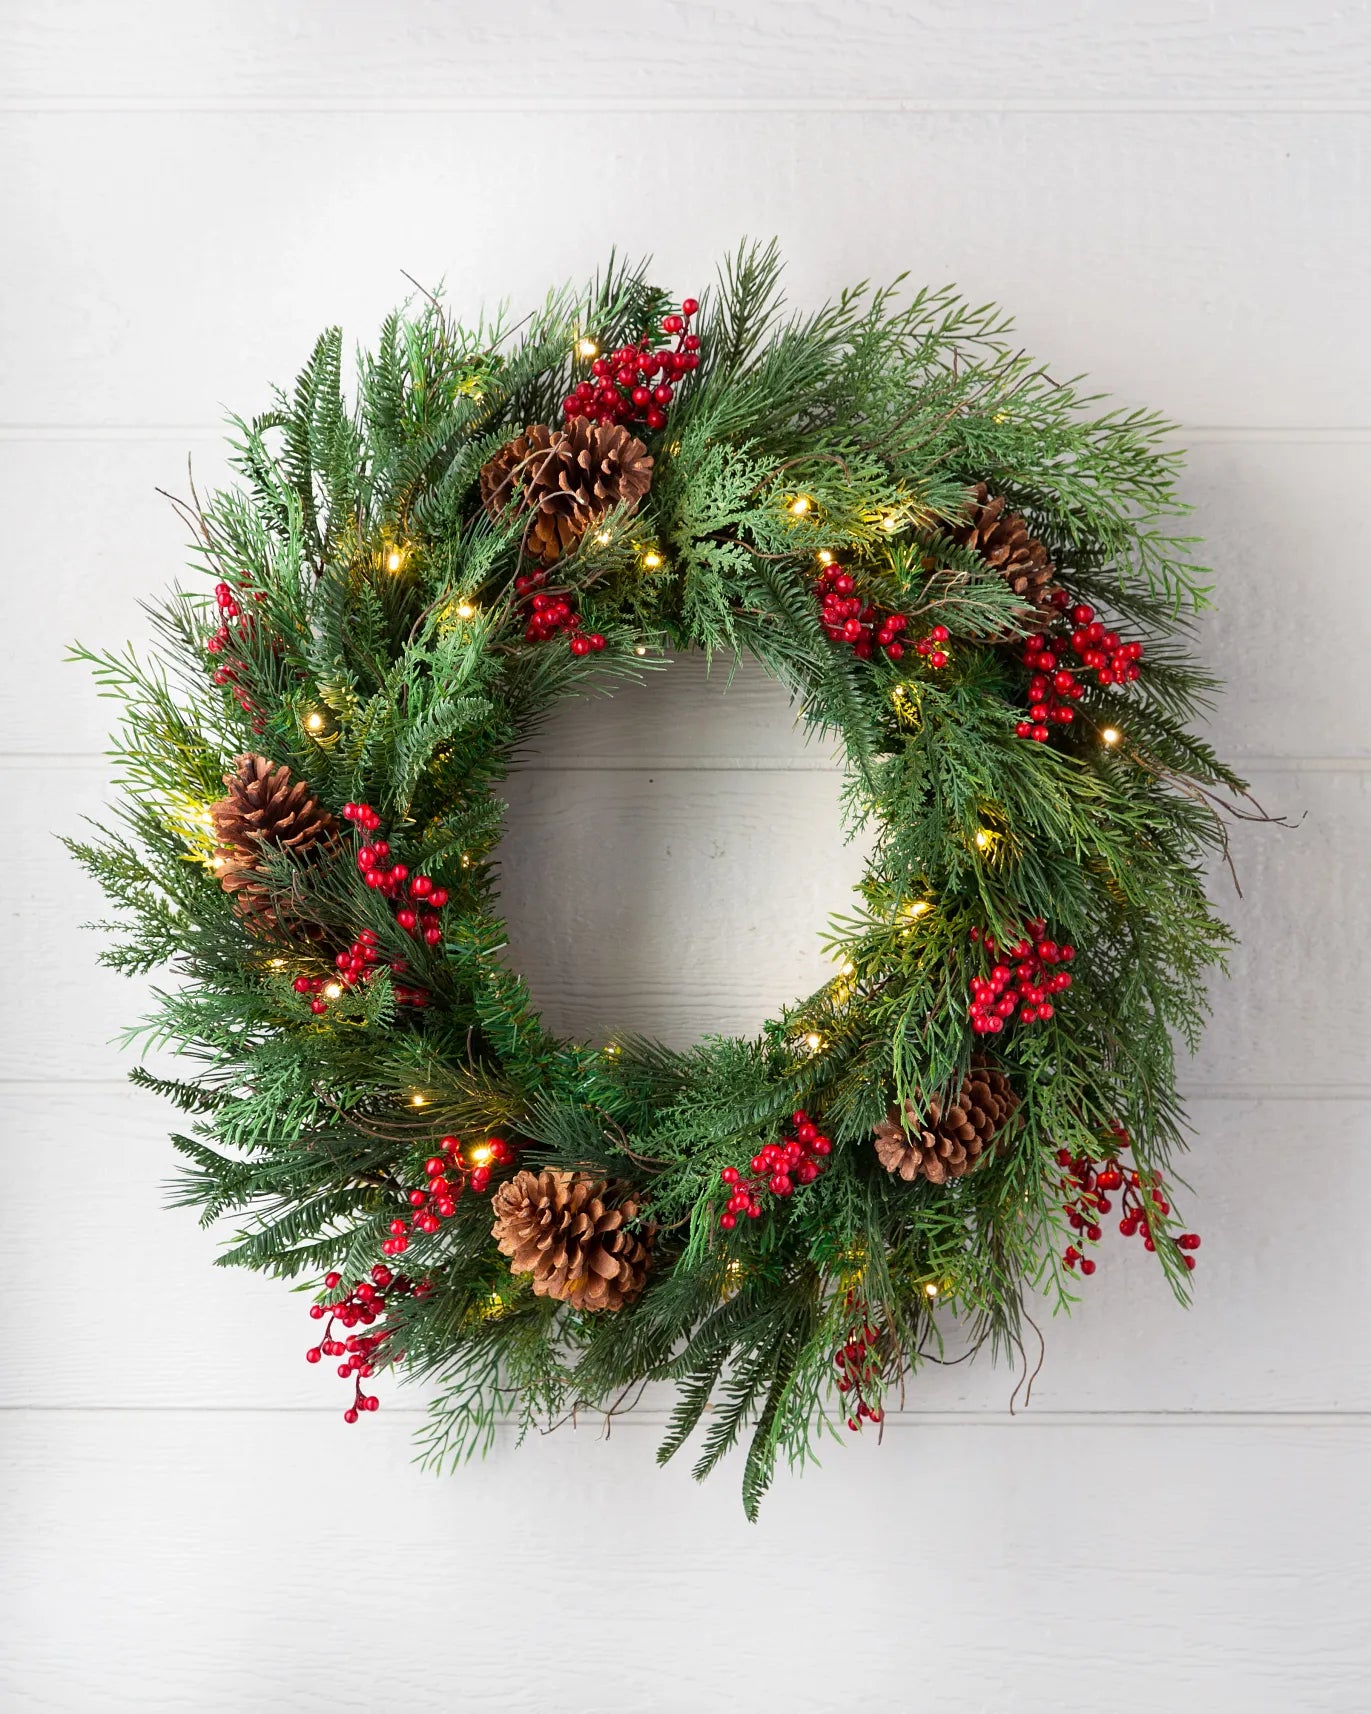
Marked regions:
[482,417,653,566]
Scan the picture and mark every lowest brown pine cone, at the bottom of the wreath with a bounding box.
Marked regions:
[490,1171,651,1309]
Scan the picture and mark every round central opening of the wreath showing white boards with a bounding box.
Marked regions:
[497,653,869,1047]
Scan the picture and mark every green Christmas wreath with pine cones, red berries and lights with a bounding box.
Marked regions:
[72,249,1242,1512]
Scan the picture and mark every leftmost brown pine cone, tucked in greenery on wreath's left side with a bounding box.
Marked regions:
[209,756,338,939]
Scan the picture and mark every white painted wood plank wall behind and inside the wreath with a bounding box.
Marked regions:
[0,0,1371,1714]
